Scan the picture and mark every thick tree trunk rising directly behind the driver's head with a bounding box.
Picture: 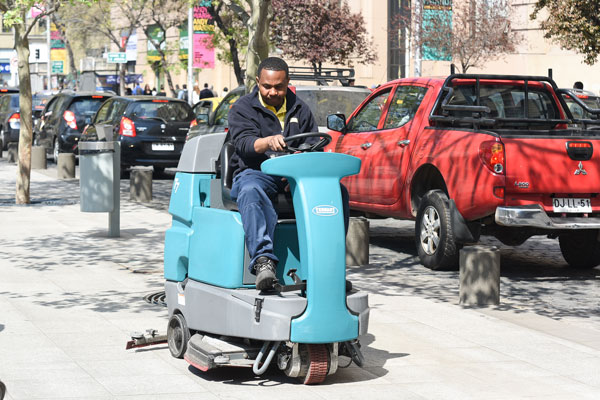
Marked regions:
[246,0,273,93]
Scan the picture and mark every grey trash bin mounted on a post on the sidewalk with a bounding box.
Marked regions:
[79,141,121,237]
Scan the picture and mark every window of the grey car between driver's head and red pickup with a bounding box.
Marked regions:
[296,87,371,126]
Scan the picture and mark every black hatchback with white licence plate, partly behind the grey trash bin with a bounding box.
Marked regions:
[82,96,194,173]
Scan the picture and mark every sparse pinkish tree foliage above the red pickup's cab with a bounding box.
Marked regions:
[414,0,522,73]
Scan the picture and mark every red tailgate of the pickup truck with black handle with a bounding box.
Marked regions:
[502,136,600,195]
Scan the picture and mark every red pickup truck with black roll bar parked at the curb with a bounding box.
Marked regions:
[327,74,600,269]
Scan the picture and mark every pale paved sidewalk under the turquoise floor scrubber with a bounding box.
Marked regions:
[0,159,600,400]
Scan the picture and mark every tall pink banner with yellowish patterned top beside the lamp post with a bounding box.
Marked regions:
[193,0,215,68]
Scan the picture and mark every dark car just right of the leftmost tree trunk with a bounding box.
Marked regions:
[35,91,112,162]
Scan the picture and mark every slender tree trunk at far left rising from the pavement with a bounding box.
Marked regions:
[14,21,33,204]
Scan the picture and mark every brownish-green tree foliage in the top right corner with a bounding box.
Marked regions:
[531,0,600,65]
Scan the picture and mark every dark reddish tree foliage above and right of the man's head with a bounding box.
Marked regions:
[272,0,377,72]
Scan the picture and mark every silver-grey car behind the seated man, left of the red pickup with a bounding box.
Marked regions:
[187,85,371,140]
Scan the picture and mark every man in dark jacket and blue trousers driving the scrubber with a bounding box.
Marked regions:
[227,57,348,290]
